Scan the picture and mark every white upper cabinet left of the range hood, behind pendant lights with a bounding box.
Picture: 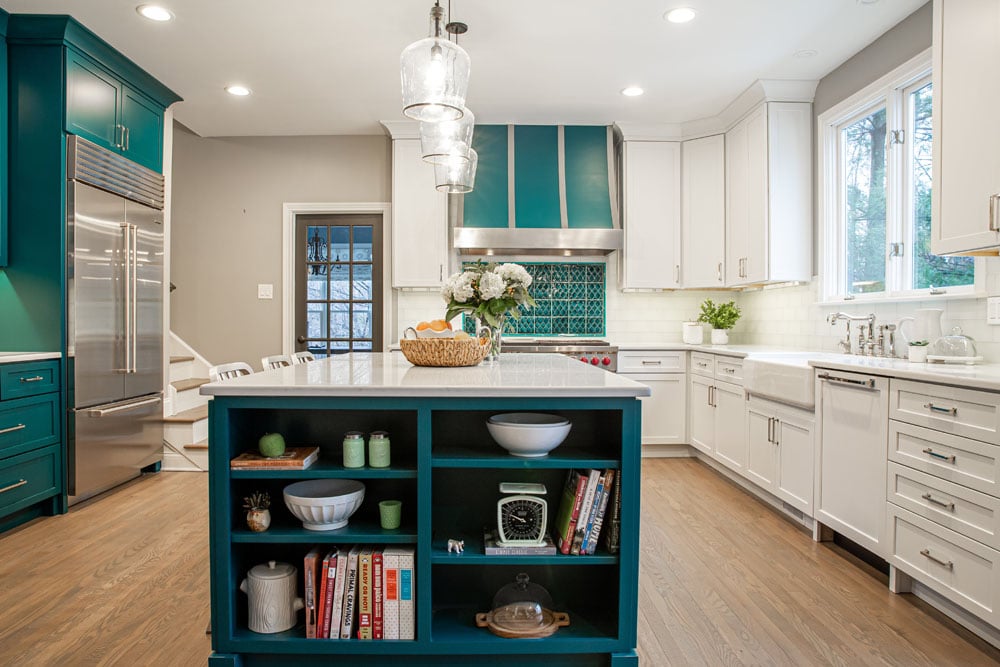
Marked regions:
[392,139,448,288]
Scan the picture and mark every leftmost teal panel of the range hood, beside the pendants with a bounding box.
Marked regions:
[463,125,509,227]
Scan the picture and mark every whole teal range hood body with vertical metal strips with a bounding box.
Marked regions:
[462,125,617,229]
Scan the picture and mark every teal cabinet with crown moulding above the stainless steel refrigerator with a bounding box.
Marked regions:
[10,14,180,171]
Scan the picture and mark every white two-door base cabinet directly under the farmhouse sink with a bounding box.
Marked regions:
[746,396,816,516]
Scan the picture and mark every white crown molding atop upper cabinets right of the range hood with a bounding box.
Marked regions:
[615,79,819,141]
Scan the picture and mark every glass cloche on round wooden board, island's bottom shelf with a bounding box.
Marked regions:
[476,572,569,639]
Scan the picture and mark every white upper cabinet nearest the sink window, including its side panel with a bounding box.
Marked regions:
[725,102,813,286]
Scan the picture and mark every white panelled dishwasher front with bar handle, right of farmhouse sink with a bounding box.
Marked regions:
[815,369,889,558]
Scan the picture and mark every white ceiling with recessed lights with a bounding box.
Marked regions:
[0,0,926,136]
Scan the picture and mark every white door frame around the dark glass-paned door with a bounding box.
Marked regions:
[281,202,393,354]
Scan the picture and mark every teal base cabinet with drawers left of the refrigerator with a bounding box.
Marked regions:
[0,360,66,530]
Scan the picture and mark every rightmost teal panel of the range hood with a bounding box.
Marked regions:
[564,125,614,229]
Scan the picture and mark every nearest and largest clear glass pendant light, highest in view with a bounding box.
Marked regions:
[399,2,470,123]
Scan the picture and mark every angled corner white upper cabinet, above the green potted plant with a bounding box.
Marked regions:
[681,134,726,288]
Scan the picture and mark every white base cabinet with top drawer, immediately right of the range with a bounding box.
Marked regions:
[618,350,688,445]
